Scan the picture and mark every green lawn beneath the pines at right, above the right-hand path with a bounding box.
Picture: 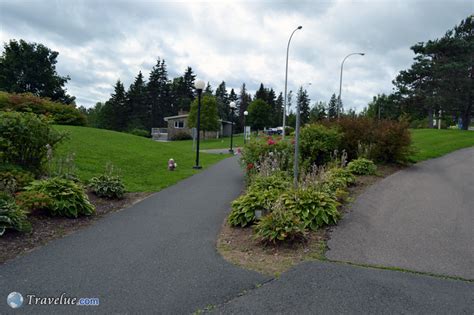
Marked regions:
[410,129,474,162]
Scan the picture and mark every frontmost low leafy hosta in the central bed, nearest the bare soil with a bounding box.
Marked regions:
[254,207,306,244]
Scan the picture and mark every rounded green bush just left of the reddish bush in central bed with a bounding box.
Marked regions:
[300,125,341,166]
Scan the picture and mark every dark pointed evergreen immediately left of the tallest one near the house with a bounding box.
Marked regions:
[126,71,151,131]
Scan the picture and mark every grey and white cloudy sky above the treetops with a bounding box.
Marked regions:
[0,0,474,110]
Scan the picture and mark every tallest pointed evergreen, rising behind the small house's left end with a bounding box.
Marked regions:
[147,58,174,128]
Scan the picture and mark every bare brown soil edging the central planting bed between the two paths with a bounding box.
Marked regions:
[217,165,403,276]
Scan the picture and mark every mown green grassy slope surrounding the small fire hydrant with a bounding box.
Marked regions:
[55,126,227,192]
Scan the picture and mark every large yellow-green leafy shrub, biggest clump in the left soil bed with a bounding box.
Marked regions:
[27,177,95,218]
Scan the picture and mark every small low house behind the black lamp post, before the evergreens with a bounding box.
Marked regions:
[154,112,232,140]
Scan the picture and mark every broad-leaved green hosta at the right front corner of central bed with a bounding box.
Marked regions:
[279,189,340,231]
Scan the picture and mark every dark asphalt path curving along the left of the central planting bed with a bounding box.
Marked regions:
[0,158,268,314]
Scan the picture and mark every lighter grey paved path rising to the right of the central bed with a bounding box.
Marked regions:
[327,148,474,279]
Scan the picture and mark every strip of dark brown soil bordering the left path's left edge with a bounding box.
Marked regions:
[0,193,151,264]
